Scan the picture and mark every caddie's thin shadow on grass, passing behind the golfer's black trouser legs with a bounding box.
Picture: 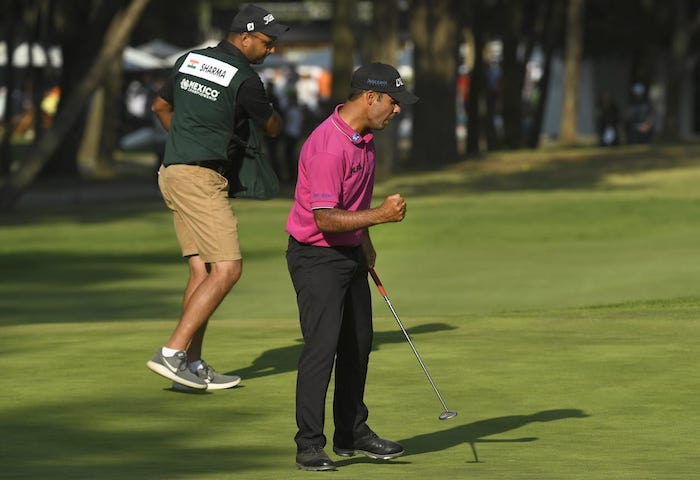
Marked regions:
[227,323,455,379]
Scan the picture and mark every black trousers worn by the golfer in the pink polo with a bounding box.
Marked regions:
[287,237,373,450]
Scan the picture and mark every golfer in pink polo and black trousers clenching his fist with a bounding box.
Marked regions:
[286,63,418,470]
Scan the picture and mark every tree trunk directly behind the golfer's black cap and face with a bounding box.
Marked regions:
[362,0,402,173]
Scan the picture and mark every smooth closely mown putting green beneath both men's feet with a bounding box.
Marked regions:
[0,306,700,479]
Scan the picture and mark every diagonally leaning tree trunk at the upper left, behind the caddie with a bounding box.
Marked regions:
[0,0,149,209]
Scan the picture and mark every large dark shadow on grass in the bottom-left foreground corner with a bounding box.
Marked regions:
[0,395,278,480]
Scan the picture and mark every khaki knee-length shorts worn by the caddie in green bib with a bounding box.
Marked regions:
[158,165,241,263]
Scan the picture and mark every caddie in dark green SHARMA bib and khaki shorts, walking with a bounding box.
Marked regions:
[147,5,289,390]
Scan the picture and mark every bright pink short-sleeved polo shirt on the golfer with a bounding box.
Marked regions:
[286,105,375,247]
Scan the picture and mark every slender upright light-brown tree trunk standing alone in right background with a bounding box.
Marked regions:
[560,0,584,145]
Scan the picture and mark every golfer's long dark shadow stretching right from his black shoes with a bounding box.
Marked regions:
[392,409,590,462]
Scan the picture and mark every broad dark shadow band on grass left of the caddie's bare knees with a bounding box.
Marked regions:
[0,246,282,326]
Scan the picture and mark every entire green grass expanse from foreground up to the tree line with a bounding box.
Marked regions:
[0,150,700,480]
